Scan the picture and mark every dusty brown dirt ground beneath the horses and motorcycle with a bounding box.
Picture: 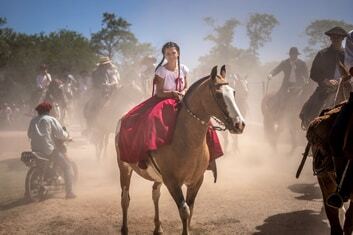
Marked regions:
[0,125,329,235]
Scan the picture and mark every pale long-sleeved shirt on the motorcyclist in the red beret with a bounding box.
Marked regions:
[27,115,69,155]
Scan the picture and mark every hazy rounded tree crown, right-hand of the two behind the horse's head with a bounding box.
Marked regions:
[246,13,279,55]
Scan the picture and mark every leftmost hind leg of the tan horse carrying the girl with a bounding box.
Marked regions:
[118,160,132,234]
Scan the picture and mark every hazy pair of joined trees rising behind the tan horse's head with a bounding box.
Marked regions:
[196,13,278,76]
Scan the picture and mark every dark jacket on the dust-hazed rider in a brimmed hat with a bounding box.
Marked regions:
[271,59,308,89]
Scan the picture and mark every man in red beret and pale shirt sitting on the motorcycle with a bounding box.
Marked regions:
[27,102,76,199]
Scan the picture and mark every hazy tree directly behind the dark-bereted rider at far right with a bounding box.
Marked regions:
[304,19,353,58]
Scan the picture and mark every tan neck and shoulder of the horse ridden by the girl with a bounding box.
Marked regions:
[172,83,210,150]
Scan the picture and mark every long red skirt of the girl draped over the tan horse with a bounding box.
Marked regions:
[115,96,223,163]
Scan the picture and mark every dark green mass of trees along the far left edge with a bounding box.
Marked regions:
[0,25,96,98]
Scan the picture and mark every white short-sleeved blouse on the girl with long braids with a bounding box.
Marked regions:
[156,64,189,91]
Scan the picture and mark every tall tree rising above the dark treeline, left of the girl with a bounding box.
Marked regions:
[91,12,136,58]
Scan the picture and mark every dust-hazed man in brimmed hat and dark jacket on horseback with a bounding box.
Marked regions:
[267,47,308,115]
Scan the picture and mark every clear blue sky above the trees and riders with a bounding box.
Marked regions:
[0,0,353,68]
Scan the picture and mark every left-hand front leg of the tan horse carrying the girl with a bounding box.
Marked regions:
[163,177,190,235]
